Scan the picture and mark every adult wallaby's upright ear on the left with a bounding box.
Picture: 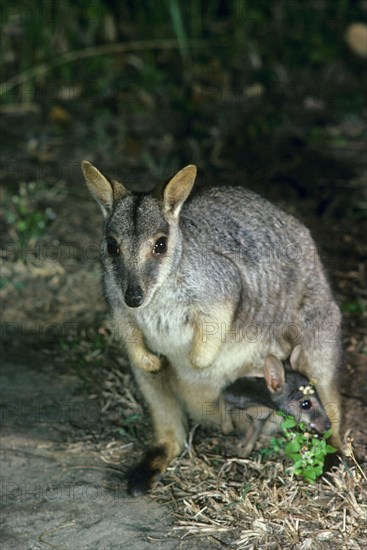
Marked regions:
[82,160,128,218]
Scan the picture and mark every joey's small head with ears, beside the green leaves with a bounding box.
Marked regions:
[264,346,331,433]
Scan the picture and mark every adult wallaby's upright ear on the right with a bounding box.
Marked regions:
[163,164,197,217]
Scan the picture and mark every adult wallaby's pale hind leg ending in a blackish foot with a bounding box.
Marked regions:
[128,365,186,496]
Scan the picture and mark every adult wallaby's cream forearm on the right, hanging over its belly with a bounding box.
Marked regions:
[189,306,232,369]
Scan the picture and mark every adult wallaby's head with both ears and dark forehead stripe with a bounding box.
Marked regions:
[82,161,196,308]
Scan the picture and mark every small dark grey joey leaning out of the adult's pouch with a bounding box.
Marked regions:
[222,345,331,457]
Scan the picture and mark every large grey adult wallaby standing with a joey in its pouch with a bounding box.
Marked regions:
[82,161,341,495]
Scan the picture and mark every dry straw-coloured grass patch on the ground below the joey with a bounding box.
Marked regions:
[148,430,367,550]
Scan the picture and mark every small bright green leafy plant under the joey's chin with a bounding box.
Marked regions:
[263,412,337,483]
